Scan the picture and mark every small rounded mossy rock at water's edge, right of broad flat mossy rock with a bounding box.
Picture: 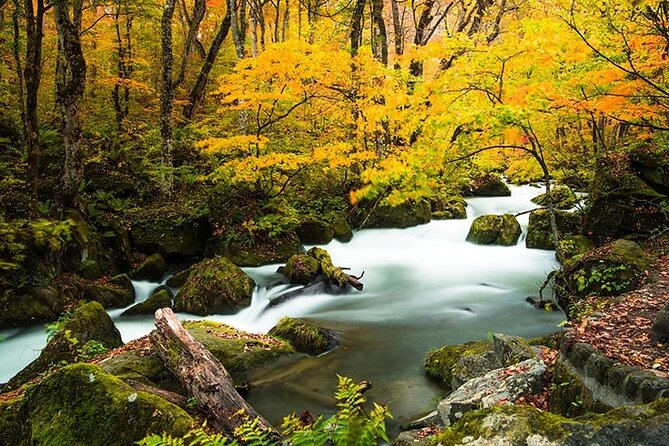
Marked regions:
[269,317,337,355]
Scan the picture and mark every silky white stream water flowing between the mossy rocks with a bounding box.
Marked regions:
[0,186,564,430]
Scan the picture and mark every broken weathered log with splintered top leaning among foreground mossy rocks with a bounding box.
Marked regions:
[151,308,280,439]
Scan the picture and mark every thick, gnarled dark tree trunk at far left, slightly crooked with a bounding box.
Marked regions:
[53,0,86,206]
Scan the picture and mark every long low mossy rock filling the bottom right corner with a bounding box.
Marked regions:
[432,398,669,446]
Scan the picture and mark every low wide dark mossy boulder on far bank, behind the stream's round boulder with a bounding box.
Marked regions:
[206,231,305,266]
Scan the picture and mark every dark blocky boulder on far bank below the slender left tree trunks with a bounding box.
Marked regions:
[130,213,211,256]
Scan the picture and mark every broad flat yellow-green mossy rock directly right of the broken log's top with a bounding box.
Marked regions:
[184,321,295,381]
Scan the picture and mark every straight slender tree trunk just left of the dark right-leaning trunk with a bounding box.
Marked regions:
[160,0,176,198]
